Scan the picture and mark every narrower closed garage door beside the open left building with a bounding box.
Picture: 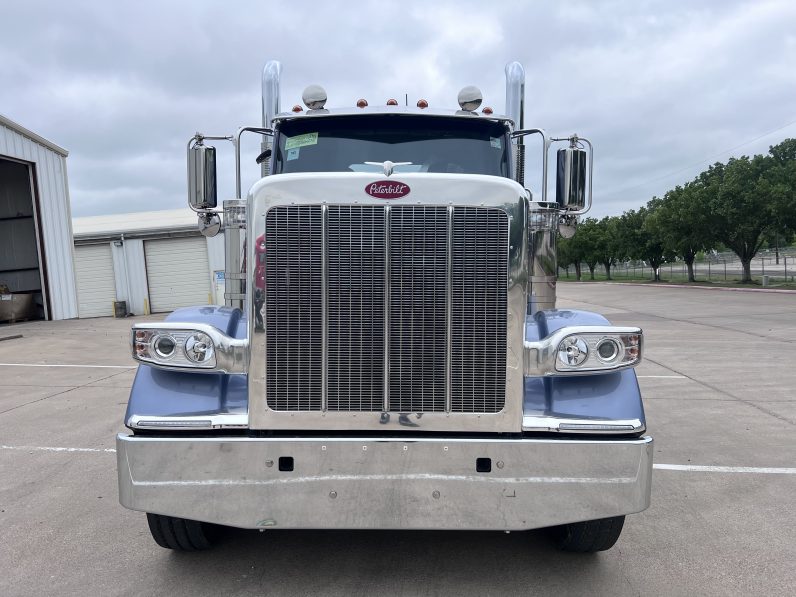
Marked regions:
[75,243,116,317]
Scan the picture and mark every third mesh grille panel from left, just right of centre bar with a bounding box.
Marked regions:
[389,206,448,412]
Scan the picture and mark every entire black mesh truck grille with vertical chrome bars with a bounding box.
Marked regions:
[265,205,508,414]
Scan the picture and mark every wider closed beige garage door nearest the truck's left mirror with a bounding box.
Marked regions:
[144,236,210,313]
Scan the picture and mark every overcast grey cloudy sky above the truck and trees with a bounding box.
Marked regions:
[0,0,796,216]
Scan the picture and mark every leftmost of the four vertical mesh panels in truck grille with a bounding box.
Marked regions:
[265,205,323,410]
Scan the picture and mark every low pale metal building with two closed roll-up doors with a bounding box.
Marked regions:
[73,209,224,317]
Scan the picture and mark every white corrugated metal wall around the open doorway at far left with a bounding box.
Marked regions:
[0,118,77,319]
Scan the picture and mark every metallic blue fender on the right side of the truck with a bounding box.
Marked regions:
[523,309,646,425]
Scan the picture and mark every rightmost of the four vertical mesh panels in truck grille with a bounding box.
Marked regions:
[450,207,508,413]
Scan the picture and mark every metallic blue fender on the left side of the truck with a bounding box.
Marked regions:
[124,306,248,422]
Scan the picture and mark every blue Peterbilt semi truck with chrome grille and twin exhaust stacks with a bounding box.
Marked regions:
[116,61,652,552]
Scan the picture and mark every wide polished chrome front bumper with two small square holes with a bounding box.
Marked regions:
[116,434,652,530]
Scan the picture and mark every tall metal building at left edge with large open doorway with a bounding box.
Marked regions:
[0,115,77,322]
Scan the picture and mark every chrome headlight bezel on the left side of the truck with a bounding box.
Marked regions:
[130,321,248,373]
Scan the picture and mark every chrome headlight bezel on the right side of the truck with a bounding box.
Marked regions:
[524,326,644,377]
